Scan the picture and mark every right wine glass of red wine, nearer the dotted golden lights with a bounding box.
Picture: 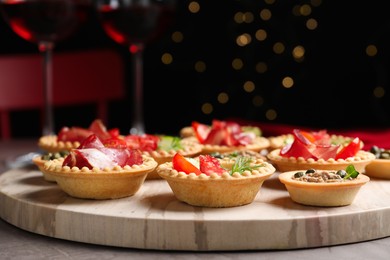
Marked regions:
[97,0,176,135]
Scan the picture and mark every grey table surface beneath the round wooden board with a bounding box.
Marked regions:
[0,140,390,260]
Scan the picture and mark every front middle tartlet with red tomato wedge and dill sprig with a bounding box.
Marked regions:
[157,153,275,208]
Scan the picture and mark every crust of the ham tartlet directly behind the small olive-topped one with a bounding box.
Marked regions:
[267,149,375,173]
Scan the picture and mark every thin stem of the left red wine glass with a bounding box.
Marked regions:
[39,42,55,135]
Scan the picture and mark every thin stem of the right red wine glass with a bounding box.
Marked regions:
[130,44,145,135]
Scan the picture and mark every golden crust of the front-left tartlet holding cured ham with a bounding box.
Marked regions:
[43,155,157,199]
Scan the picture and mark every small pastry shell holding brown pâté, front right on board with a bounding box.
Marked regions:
[278,170,370,207]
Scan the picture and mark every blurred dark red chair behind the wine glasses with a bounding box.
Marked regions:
[0,49,125,140]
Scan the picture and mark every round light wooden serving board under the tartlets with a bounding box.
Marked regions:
[0,168,390,251]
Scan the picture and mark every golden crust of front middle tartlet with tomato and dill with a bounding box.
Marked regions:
[157,158,275,208]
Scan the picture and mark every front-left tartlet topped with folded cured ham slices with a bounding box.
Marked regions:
[42,135,157,199]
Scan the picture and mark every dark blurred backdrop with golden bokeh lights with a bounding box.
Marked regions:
[0,0,390,137]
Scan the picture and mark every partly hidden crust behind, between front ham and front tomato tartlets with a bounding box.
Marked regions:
[143,140,202,180]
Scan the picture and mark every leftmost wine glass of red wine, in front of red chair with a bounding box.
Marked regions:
[0,0,92,169]
